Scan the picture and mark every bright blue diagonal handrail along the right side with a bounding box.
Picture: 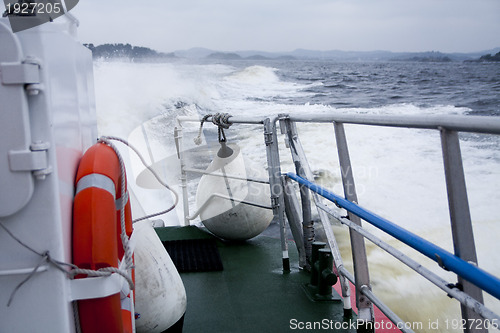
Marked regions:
[286,172,500,299]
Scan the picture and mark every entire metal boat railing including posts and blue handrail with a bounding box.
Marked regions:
[176,113,500,332]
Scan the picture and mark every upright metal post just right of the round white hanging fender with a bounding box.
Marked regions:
[264,118,290,272]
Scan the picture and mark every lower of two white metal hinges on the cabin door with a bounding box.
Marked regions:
[9,142,52,179]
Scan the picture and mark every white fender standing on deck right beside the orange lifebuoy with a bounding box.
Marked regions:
[134,220,186,333]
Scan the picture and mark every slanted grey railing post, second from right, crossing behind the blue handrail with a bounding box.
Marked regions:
[333,123,374,321]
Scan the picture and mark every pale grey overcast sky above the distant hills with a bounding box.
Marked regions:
[6,0,500,52]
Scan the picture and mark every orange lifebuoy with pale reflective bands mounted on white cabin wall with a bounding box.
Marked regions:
[73,143,134,333]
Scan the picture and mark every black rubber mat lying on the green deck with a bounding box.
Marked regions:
[162,239,223,273]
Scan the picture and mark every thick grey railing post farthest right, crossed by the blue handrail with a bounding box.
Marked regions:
[441,128,487,332]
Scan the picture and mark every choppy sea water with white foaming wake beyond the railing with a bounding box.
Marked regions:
[95,60,500,332]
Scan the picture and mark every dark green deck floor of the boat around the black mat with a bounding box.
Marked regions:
[157,227,356,333]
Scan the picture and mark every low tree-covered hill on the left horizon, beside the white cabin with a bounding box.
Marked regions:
[84,44,175,61]
